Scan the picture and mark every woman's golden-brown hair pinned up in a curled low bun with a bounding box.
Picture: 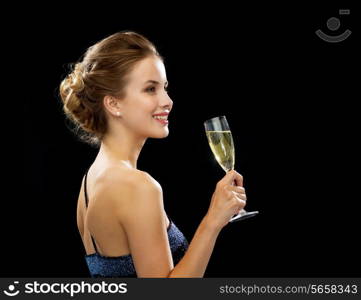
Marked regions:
[60,31,162,145]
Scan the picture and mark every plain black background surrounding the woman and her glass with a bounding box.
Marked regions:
[9,2,361,277]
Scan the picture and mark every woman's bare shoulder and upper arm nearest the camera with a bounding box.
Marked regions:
[89,167,174,277]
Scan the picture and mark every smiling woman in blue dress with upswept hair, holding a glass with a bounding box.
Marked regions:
[60,32,246,278]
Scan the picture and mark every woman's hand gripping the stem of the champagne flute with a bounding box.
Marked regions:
[206,170,247,229]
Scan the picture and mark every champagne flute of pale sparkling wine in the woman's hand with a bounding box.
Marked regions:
[204,116,258,222]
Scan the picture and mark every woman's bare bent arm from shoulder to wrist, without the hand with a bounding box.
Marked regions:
[107,171,220,278]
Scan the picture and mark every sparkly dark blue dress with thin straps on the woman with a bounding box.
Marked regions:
[84,172,188,277]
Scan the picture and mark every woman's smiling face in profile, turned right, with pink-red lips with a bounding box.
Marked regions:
[121,56,173,138]
